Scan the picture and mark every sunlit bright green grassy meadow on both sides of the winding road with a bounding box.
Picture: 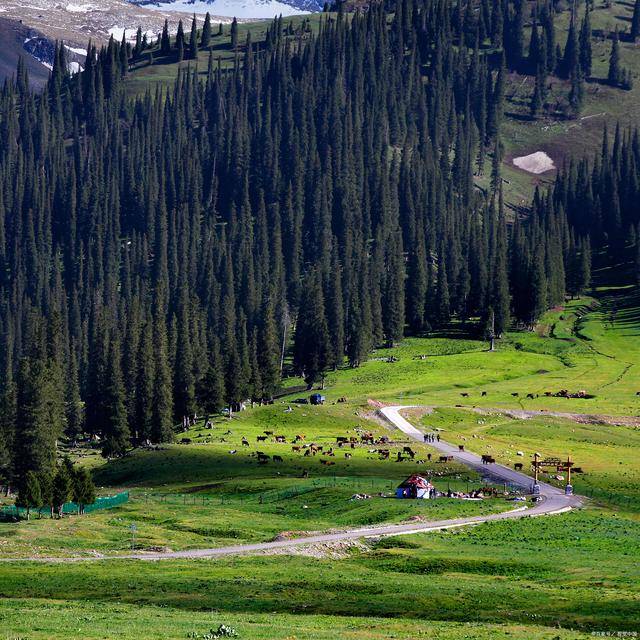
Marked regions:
[0,276,640,640]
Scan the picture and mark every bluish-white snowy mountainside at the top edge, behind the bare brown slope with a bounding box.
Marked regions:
[129,0,322,19]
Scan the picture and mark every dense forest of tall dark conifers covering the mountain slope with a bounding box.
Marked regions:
[0,0,640,496]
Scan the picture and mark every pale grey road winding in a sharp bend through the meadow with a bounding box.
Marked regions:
[0,407,581,562]
